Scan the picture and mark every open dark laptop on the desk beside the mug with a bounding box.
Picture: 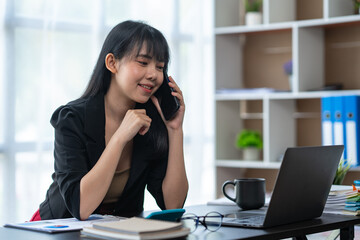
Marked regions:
[222,145,344,228]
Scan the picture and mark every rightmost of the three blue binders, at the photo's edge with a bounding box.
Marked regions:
[343,96,360,166]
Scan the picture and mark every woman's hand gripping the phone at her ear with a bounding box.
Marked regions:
[151,77,185,130]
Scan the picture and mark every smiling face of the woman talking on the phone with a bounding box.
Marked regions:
[112,44,165,103]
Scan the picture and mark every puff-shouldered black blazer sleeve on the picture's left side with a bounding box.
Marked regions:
[51,106,89,219]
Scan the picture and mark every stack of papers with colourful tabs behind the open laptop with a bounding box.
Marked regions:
[324,185,360,216]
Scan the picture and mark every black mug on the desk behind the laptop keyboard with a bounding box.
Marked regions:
[222,178,265,210]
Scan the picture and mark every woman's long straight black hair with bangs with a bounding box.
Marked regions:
[81,21,170,157]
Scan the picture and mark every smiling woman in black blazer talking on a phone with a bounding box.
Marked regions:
[32,21,188,220]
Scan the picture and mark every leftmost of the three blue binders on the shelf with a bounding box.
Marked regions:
[321,97,334,145]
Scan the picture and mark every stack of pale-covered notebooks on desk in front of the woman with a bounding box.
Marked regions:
[81,217,190,239]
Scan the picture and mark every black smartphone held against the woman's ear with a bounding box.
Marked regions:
[155,72,180,121]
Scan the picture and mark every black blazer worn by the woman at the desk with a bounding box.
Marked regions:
[40,94,168,219]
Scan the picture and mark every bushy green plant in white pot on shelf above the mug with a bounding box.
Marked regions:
[235,129,263,160]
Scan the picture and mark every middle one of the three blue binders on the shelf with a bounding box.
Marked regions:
[332,96,347,159]
